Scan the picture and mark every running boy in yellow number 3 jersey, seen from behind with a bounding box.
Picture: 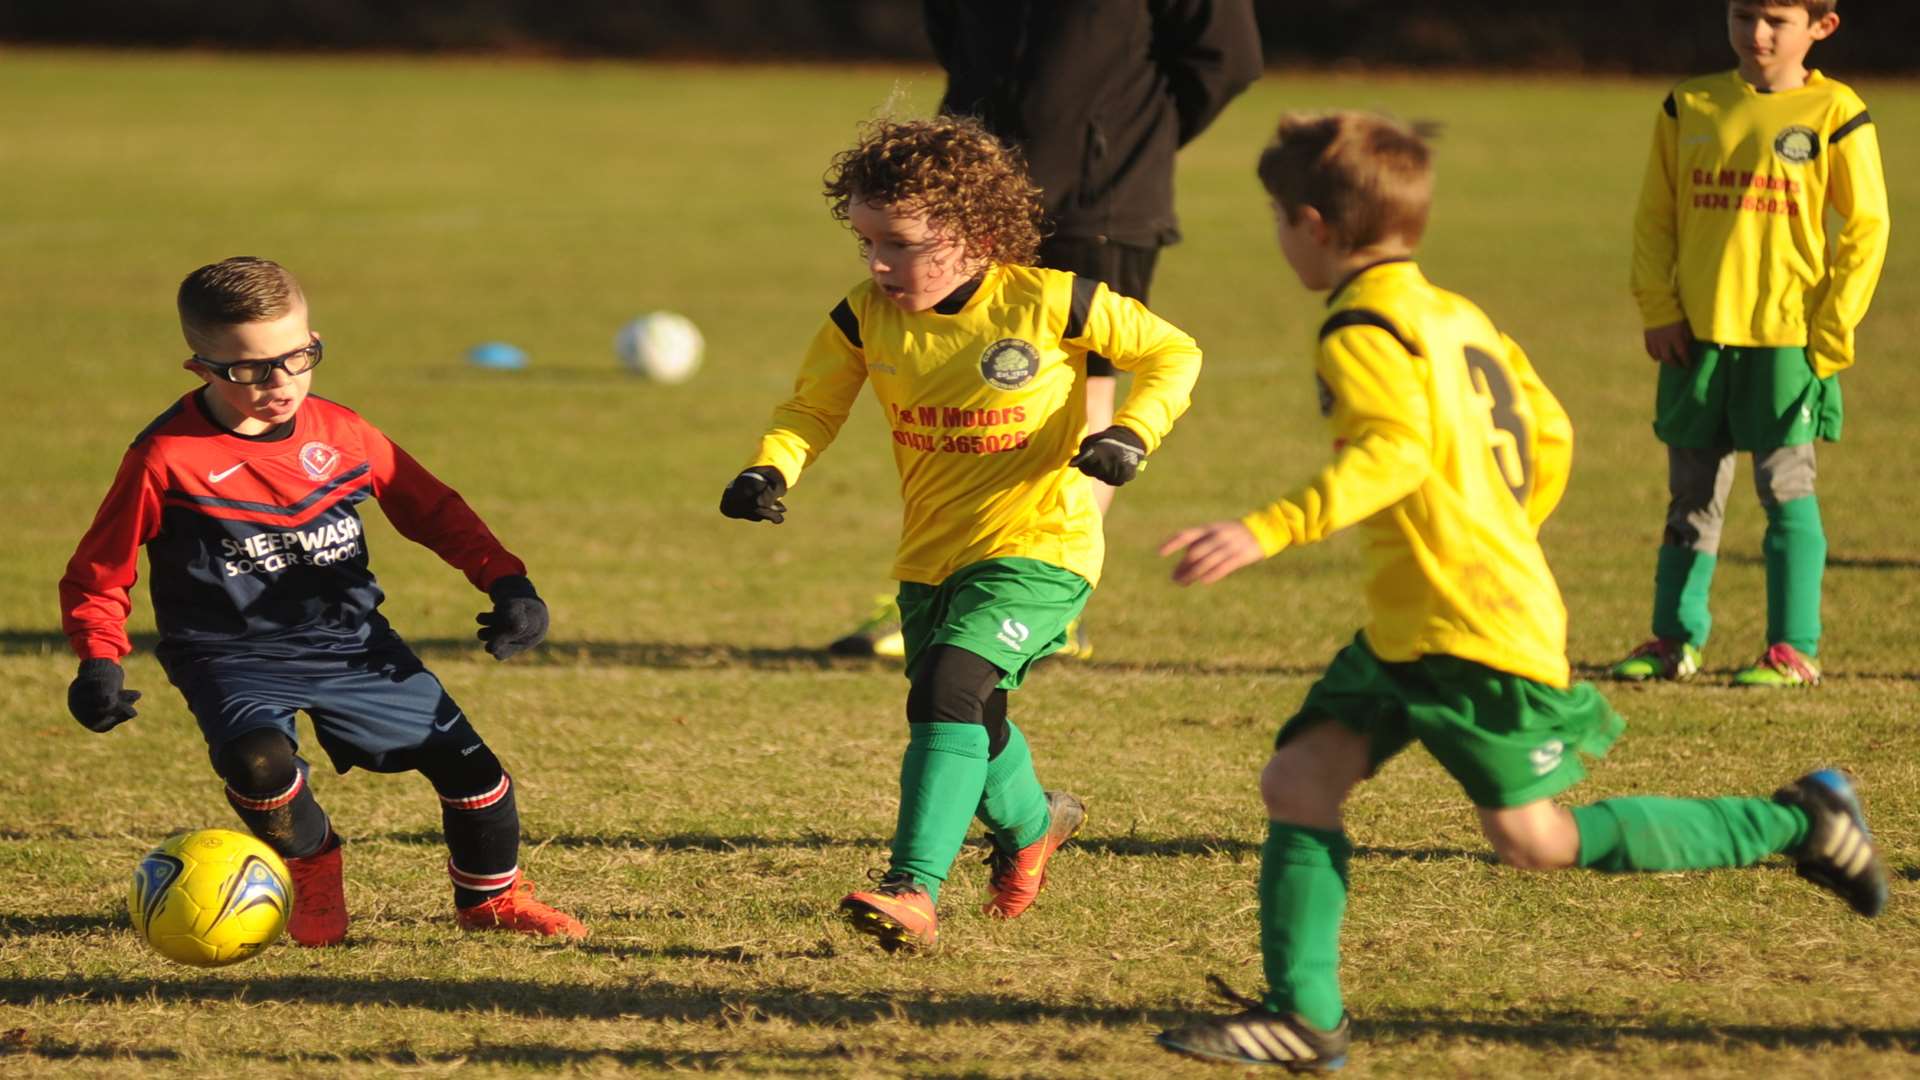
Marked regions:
[1160,113,1887,1070]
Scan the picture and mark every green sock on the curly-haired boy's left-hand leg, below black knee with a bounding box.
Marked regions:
[893,724,990,899]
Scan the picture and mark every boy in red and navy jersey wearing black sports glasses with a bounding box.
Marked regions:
[60,258,588,945]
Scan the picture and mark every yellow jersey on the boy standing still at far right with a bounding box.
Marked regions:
[1632,71,1887,379]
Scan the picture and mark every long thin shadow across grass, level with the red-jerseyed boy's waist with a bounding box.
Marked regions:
[0,630,1327,678]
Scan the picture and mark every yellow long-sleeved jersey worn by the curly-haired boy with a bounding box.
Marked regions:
[749,265,1200,584]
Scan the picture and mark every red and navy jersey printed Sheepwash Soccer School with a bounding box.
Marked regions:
[60,392,526,659]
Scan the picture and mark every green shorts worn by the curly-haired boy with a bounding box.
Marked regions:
[900,559,1092,690]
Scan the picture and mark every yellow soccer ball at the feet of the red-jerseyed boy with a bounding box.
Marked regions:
[127,828,294,967]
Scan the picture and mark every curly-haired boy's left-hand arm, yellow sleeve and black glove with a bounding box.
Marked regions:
[720,300,866,525]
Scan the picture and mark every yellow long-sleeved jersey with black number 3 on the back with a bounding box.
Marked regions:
[1242,259,1572,686]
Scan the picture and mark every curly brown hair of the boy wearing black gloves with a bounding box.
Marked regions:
[826,115,1041,265]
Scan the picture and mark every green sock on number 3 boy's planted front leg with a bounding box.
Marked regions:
[1260,821,1354,1030]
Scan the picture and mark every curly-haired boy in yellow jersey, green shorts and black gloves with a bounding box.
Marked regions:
[720,117,1200,951]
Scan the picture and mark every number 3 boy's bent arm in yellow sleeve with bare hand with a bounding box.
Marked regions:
[1160,323,1432,584]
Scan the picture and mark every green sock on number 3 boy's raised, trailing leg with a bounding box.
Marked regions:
[1572,796,1807,872]
